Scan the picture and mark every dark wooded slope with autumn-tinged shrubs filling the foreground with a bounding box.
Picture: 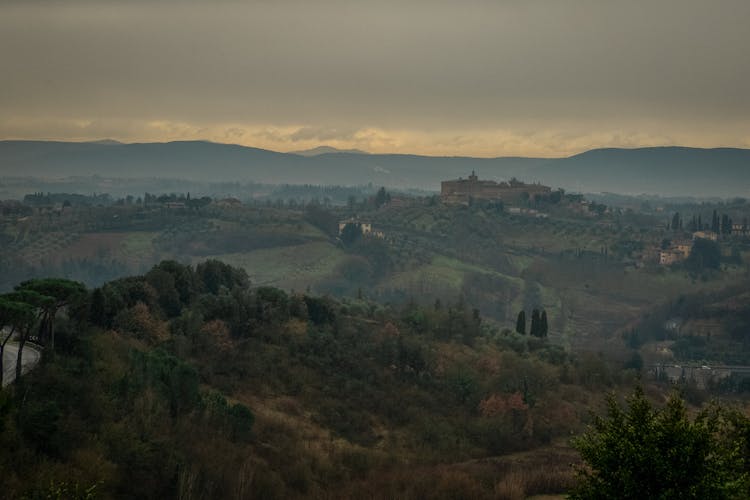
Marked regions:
[0,259,744,498]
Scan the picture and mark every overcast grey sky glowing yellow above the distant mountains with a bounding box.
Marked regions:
[0,0,750,157]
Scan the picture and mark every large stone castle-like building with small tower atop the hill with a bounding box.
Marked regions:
[440,172,551,205]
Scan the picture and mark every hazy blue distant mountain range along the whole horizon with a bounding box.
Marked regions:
[0,140,750,197]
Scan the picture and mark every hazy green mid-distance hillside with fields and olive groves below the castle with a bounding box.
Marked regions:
[0,197,750,352]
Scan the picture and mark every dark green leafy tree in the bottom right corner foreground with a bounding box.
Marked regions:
[570,387,750,499]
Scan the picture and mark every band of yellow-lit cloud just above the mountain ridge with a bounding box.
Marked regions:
[0,117,750,157]
